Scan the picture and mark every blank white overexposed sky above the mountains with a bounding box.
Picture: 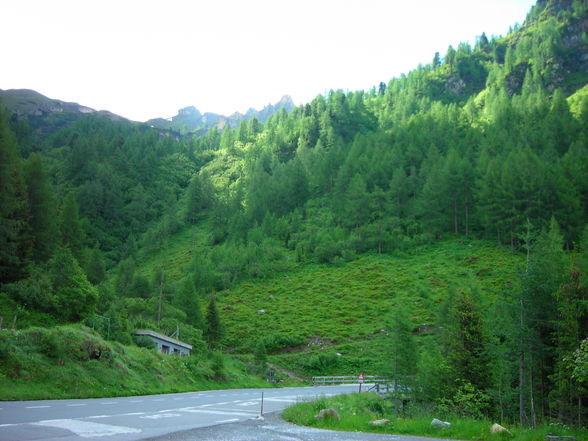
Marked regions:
[0,0,535,121]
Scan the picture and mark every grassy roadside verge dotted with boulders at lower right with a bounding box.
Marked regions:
[282,393,588,441]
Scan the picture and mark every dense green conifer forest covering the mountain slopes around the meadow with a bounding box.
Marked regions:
[0,0,588,425]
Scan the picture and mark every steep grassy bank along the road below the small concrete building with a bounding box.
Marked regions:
[0,326,268,400]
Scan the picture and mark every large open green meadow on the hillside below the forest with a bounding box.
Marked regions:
[217,240,522,357]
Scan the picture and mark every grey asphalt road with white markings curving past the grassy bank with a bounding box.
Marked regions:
[0,385,358,441]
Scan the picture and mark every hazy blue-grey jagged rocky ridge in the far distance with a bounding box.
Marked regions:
[146,95,294,133]
